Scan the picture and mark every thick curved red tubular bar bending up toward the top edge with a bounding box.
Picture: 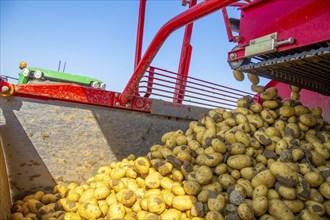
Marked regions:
[119,0,238,105]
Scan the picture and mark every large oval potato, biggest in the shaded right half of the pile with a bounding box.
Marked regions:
[270,162,298,187]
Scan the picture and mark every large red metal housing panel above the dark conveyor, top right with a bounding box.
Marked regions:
[226,0,330,61]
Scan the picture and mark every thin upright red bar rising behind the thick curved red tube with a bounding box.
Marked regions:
[134,0,147,69]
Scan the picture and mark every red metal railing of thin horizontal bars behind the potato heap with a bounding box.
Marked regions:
[138,67,255,109]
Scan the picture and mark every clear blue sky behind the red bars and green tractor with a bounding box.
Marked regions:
[0,0,268,92]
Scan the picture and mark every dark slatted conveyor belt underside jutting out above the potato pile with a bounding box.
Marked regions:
[237,46,330,95]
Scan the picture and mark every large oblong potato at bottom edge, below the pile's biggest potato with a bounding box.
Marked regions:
[268,199,295,220]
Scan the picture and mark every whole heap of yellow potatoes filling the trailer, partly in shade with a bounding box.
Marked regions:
[12,88,330,220]
